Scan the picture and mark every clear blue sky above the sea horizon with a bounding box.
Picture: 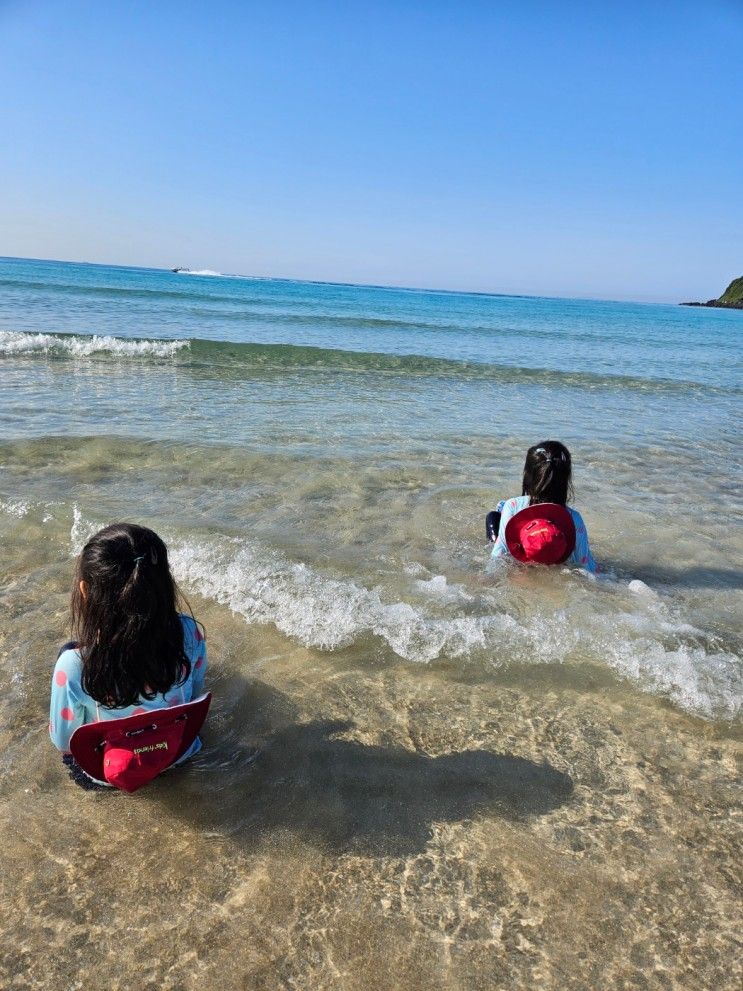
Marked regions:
[0,0,743,300]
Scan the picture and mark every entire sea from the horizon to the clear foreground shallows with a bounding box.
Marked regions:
[0,258,743,991]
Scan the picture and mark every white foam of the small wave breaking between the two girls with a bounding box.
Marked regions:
[166,540,741,719]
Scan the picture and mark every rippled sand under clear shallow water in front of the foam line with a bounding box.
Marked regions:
[0,580,742,991]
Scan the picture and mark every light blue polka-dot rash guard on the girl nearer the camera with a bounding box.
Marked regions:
[49,614,206,763]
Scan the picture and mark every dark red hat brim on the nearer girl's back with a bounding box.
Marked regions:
[70,692,212,781]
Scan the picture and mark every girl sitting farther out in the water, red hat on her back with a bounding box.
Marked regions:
[485,440,598,573]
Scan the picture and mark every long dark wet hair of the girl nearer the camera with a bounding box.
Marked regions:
[72,523,191,709]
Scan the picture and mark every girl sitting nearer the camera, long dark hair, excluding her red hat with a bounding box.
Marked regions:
[49,523,206,785]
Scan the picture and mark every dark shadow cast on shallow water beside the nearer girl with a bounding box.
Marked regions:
[155,683,573,856]
